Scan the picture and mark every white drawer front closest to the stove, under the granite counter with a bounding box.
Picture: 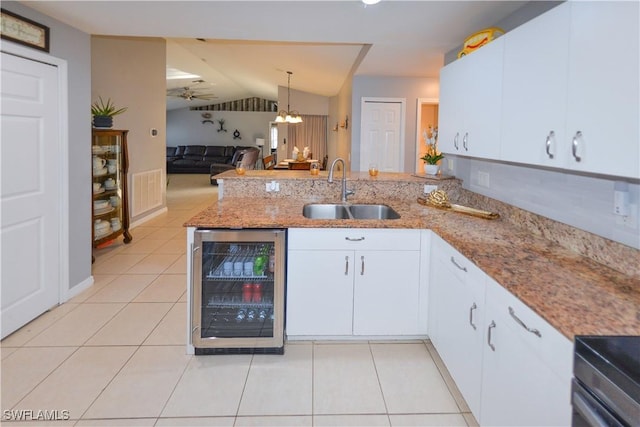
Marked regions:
[486,278,573,379]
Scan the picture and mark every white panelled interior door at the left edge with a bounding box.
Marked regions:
[0,52,61,338]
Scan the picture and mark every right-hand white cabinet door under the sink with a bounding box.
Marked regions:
[353,251,420,335]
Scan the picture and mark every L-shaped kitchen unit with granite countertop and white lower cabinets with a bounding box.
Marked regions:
[185,171,640,425]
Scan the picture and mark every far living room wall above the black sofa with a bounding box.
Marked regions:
[167,108,276,148]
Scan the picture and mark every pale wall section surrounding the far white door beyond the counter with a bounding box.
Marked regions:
[349,76,440,173]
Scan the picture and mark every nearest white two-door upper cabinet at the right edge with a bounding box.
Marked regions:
[500,2,640,178]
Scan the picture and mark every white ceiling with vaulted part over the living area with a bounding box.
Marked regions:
[24,0,527,109]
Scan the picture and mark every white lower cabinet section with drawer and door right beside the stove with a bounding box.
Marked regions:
[479,278,573,426]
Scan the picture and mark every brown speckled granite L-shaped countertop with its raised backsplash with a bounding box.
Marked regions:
[185,171,640,340]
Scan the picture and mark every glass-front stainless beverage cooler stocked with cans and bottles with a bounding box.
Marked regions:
[189,229,286,355]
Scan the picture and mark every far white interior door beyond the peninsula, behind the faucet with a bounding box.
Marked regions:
[360,99,405,172]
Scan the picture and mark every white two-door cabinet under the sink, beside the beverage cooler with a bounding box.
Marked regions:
[286,229,424,336]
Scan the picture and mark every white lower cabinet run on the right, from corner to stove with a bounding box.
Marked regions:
[429,235,573,426]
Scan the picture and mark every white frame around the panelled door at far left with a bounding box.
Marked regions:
[0,40,70,304]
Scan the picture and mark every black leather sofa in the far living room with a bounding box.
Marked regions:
[167,145,254,173]
